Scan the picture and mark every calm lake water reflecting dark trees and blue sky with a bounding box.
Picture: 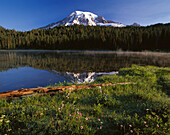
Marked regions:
[0,50,170,92]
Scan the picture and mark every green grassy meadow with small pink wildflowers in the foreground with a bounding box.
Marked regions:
[0,65,170,135]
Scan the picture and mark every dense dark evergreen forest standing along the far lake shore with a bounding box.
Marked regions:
[0,23,170,51]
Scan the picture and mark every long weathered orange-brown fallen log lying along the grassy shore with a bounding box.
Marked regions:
[0,82,135,99]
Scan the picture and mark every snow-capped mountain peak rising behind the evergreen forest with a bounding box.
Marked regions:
[42,11,125,29]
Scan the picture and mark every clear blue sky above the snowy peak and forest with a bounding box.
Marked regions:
[0,0,170,31]
